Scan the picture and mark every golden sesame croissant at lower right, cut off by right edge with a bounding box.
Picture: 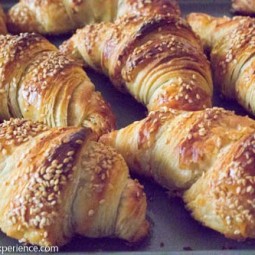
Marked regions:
[100,108,255,239]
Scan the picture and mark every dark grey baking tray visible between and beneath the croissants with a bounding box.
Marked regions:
[0,0,255,255]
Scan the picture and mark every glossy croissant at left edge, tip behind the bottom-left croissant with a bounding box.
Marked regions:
[0,33,115,138]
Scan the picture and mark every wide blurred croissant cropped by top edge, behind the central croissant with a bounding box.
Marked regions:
[8,0,179,34]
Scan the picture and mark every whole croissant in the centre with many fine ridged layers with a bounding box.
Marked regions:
[60,15,212,111]
